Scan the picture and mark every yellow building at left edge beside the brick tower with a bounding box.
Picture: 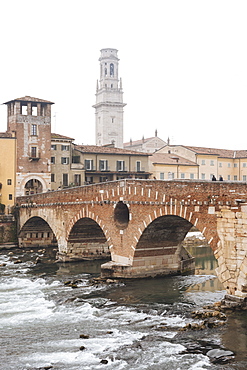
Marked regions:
[0,132,16,214]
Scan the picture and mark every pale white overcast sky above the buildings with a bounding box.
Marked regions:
[0,0,247,149]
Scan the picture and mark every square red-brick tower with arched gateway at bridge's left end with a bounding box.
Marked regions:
[4,96,53,196]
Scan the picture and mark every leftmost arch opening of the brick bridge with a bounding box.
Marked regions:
[18,216,58,247]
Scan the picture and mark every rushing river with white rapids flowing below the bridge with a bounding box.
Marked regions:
[0,234,247,370]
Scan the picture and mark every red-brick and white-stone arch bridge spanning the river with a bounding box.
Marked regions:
[17,179,247,297]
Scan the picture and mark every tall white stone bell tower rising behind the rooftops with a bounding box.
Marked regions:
[93,48,126,148]
